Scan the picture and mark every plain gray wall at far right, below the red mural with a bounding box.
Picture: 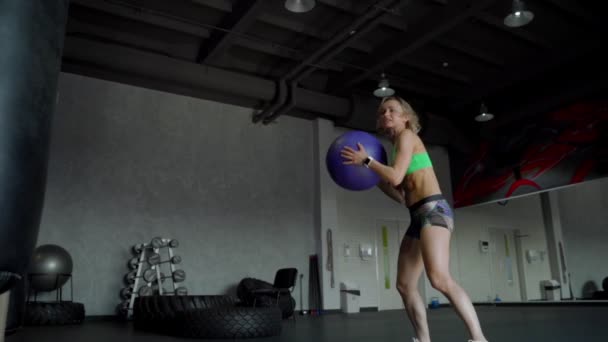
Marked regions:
[556,178,608,298]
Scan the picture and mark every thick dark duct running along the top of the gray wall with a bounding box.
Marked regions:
[63,35,350,119]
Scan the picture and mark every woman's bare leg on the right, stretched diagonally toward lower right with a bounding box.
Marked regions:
[420,226,486,341]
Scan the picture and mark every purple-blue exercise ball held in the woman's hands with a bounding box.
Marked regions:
[325,131,386,191]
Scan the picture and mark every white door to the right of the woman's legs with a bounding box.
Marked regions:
[489,228,521,302]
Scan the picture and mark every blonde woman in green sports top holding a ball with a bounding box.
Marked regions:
[341,96,486,342]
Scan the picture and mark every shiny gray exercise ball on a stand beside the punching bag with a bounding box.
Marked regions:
[28,244,73,291]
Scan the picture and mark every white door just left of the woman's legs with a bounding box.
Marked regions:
[376,220,405,310]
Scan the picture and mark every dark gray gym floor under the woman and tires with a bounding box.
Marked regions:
[6,306,608,342]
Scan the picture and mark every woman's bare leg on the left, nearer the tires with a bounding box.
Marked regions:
[397,235,431,342]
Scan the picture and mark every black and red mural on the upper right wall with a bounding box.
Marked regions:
[454,101,608,207]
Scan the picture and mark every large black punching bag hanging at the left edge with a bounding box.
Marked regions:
[0,0,69,294]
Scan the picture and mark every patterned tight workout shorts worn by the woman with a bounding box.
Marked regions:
[405,195,454,240]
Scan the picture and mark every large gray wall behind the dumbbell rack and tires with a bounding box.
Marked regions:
[38,73,315,315]
